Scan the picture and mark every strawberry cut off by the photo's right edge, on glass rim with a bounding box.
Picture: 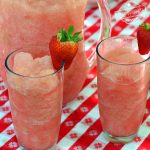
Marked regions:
[137,23,150,55]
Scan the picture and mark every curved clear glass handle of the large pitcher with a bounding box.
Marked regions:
[87,0,111,70]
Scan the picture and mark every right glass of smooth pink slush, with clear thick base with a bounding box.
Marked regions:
[97,36,150,143]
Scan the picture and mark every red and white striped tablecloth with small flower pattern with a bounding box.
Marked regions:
[0,0,150,150]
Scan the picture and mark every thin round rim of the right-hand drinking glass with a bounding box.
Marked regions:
[96,35,150,66]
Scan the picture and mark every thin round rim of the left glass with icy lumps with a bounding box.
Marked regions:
[4,46,65,79]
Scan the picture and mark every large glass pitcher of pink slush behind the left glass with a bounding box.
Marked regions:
[0,0,110,104]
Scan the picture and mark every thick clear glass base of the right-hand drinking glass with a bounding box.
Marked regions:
[104,132,137,143]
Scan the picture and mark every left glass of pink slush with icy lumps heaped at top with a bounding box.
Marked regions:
[5,46,63,150]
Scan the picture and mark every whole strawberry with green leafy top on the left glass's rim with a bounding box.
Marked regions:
[49,26,83,69]
